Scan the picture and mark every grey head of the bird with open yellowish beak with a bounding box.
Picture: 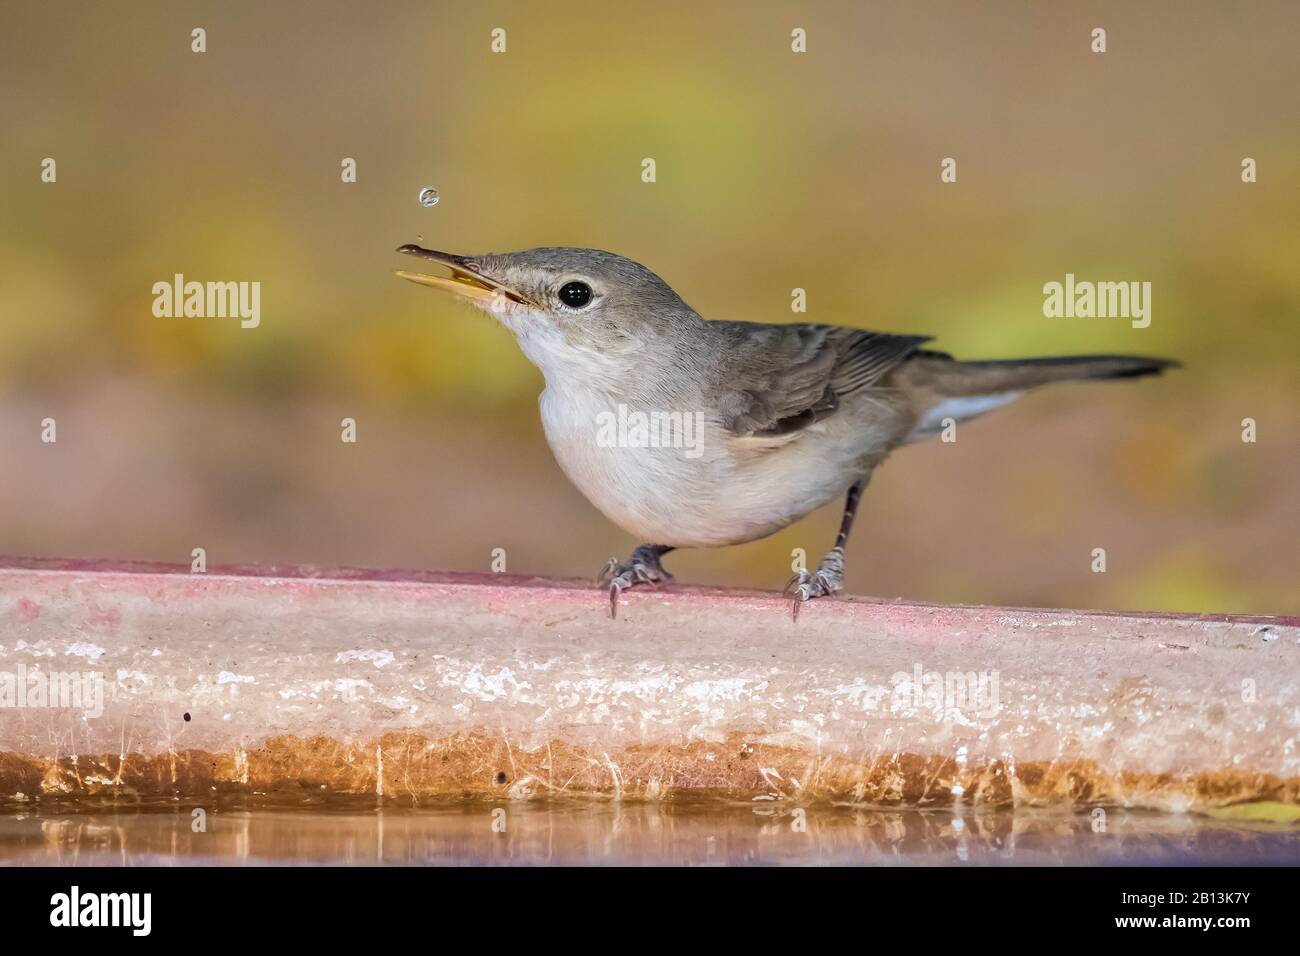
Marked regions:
[397,245,701,372]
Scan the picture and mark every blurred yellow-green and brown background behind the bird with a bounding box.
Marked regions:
[0,0,1300,613]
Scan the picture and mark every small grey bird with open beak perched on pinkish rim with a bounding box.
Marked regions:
[397,245,1177,619]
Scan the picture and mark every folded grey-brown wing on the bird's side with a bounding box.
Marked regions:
[719,323,930,437]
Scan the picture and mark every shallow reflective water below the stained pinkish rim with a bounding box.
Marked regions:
[0,803,1300,865]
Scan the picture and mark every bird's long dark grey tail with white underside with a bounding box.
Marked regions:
[906,351,1178,442]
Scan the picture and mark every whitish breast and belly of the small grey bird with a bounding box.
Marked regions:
[519,321,878,548]
